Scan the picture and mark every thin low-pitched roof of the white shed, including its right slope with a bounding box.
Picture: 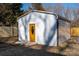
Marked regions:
[17,10,71,23]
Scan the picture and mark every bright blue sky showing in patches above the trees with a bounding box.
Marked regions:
[21,3,79,11]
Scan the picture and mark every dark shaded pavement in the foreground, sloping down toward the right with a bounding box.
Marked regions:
[0,42,61,56]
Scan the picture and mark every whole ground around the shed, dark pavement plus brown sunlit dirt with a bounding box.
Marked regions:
[0,37,79,56]
